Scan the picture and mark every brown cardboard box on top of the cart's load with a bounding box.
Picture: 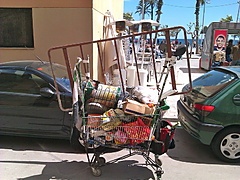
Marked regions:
[123,99,155,115]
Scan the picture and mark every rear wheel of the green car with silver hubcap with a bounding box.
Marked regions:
[211,127,240,163]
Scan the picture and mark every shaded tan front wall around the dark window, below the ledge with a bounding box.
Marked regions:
[0,8,92,63]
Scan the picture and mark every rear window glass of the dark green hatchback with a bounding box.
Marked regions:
[192,70,237,97]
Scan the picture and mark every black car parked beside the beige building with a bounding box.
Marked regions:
[0,60,72,139]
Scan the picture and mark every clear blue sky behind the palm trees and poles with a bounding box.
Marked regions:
[124,0,240,37]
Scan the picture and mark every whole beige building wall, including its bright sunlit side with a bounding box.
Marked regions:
[0,0,123,79]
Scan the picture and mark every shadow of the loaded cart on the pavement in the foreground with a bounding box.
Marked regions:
[1,160,154,180]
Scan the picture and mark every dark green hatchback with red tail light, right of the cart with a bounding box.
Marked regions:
[177,66,240,162]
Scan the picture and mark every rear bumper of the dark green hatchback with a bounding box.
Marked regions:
[177,100,223,145]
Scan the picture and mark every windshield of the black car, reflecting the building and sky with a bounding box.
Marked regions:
[31,63,71,91]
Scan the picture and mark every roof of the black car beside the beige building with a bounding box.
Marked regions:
[0,60,49,69]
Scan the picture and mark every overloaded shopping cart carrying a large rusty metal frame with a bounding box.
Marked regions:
[48,27,191,179]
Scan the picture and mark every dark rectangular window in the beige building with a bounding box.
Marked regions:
[0,8,34,48]
